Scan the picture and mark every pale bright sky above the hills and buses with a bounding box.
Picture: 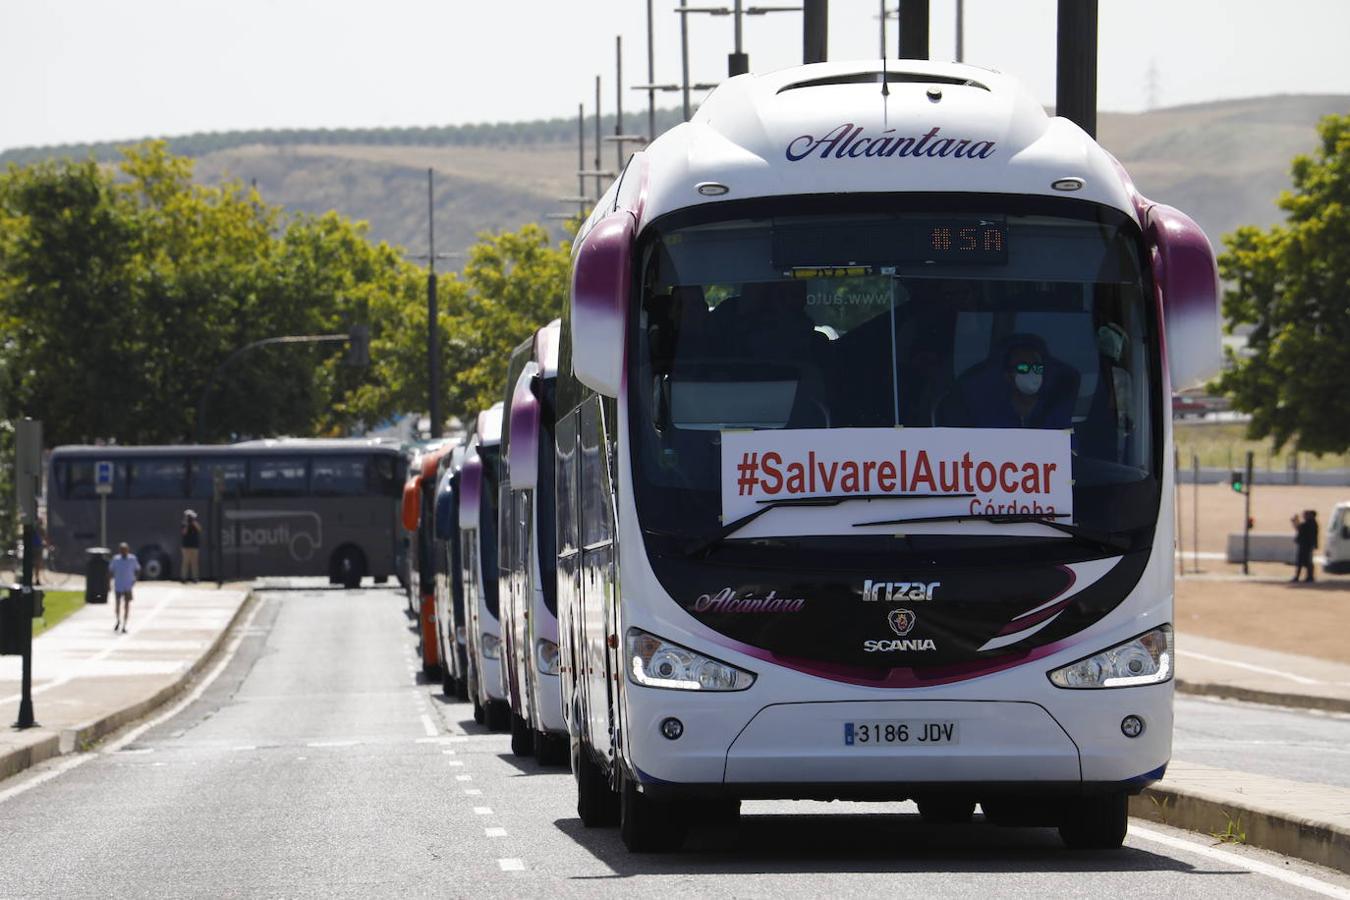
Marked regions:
[0,0,1350,150]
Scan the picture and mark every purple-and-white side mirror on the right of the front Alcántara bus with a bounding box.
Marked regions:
[1146,204,1223,390]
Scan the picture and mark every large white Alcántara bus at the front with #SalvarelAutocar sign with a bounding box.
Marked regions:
[558,61,1219,850]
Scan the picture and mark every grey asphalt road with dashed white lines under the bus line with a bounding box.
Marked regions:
[0,590,1350,900]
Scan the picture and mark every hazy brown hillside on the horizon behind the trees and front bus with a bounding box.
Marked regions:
[0,94,1350,261]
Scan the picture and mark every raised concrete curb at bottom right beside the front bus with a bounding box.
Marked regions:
[1130,783,1350,873]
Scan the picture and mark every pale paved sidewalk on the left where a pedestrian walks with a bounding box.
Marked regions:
[0,583,250,779]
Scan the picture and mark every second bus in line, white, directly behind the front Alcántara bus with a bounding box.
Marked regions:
[497,320,567,765]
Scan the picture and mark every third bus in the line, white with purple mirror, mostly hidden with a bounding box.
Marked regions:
[459,403,510,731]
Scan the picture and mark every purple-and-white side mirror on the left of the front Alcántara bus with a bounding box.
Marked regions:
[567,210,637,396]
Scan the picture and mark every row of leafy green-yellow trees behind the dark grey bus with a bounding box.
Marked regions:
[0,142,568,444]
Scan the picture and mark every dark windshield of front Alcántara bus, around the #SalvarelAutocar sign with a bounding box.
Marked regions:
[629,197,1160,552]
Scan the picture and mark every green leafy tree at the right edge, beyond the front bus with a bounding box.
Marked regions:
[1219,116,1350,453]
